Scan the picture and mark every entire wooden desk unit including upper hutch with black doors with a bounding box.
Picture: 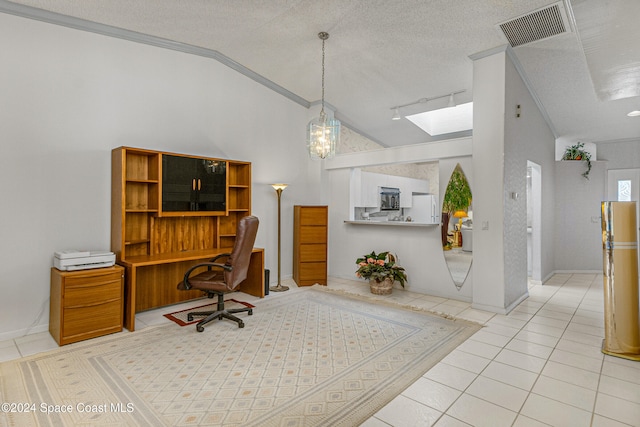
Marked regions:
[111,147,264,331]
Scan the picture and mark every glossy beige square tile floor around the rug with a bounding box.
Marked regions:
[0,274,640,427]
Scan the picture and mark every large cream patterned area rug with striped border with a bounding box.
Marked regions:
[0,287,480,427]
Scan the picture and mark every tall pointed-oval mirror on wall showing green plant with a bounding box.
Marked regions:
[442,163,473,290]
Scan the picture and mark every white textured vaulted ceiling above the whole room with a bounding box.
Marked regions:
[5,0,640,146]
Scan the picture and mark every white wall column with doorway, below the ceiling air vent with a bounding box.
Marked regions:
[473,51,555,312]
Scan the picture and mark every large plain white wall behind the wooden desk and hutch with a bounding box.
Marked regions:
[0,14,321,340]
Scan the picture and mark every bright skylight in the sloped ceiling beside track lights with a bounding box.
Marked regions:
[406,102,473,136]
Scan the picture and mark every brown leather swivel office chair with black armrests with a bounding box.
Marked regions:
[178,216,259,332]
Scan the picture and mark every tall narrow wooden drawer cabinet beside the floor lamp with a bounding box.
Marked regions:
[293,205,329,286]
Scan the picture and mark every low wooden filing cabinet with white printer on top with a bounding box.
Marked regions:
[49,265,124,345]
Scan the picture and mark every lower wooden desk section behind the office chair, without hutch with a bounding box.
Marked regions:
[119,248,264,331]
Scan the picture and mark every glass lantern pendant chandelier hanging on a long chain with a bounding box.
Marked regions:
[307,32,340,159]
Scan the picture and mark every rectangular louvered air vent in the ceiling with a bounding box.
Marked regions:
[497,2,571,47]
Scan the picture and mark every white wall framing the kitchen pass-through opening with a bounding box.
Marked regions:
[326,138,473,301]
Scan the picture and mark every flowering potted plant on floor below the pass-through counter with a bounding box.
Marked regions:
[356,252,407,295]
